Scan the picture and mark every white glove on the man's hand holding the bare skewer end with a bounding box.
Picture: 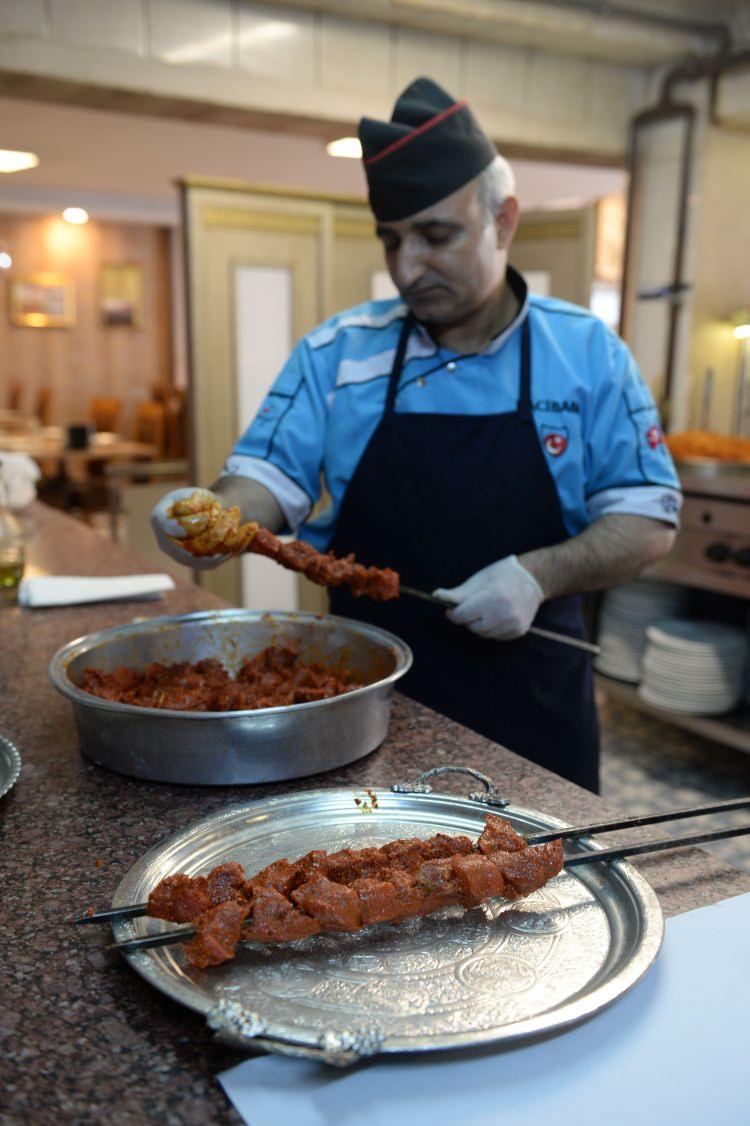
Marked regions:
[432,555,544,641]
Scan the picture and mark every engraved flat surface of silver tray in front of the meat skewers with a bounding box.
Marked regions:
[201,879,609,1037]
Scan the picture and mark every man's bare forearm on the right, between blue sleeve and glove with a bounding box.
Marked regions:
[518,513,676,598]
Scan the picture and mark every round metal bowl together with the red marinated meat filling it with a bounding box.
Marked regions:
[50,609,411,785]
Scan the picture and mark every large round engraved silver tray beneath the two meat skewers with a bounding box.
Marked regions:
[113,767,663,1064]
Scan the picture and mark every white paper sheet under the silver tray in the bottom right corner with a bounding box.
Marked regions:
[218,894,750,1126]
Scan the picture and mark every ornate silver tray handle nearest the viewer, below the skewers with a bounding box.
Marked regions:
[206,1001,384,1067]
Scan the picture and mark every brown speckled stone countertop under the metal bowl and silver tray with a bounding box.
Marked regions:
[0,504,750,1126]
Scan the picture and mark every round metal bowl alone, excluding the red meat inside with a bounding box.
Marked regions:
[50,610,412,786]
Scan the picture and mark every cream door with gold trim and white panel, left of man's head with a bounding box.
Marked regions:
[182,180,383,613]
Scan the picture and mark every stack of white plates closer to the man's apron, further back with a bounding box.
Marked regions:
[593,579,685,683]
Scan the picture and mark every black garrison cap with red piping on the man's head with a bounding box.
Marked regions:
[359,78,497,222]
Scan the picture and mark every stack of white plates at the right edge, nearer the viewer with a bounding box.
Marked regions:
[639,618,745,715]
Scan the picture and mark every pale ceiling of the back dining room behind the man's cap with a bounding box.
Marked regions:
[0,98,625,224]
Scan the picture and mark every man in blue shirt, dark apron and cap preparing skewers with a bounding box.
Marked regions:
[153,79,680,790]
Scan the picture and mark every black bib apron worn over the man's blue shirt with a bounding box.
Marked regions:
[330,304,599,793]
